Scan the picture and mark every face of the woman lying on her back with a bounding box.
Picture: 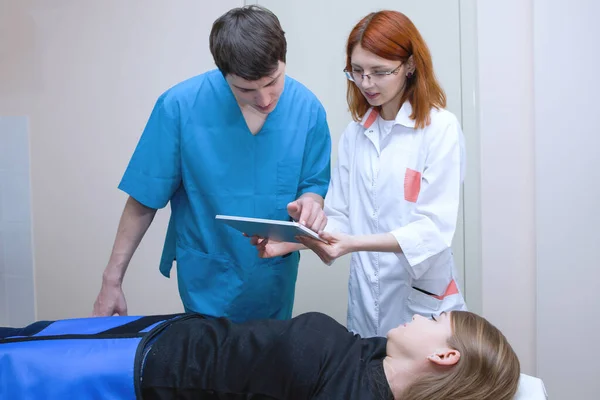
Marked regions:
[387,313,452,362]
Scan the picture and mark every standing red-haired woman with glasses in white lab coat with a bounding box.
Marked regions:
[255,11,466,337]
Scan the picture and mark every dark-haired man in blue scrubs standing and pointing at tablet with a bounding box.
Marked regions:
[94,6,331,321]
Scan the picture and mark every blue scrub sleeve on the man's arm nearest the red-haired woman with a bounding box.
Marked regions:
[296,104,331,198]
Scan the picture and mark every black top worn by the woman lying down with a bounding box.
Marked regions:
[141,313,392,400]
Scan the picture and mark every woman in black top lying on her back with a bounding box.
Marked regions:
[0,311,520,400]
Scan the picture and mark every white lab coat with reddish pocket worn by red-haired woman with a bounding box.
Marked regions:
[325,102,466,337]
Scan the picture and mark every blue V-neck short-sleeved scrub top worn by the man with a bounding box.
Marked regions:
[119,70,331,321]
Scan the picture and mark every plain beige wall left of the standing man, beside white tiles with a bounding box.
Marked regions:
[0,0,243,319]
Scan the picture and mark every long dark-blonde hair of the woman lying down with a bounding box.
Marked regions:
[399,311,520,400]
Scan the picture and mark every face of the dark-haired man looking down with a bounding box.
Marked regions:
[225,61,285,114]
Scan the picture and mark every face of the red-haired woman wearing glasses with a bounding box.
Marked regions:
[350,44,408,112]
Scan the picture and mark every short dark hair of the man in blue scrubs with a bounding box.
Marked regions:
[210,5,287,81]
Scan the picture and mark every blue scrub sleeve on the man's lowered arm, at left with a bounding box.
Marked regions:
[119,93,181,209]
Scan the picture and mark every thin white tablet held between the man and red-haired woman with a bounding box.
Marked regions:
[215,215,322,243]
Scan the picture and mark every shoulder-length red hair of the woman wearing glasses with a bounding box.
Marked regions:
[346,10,446,128]
